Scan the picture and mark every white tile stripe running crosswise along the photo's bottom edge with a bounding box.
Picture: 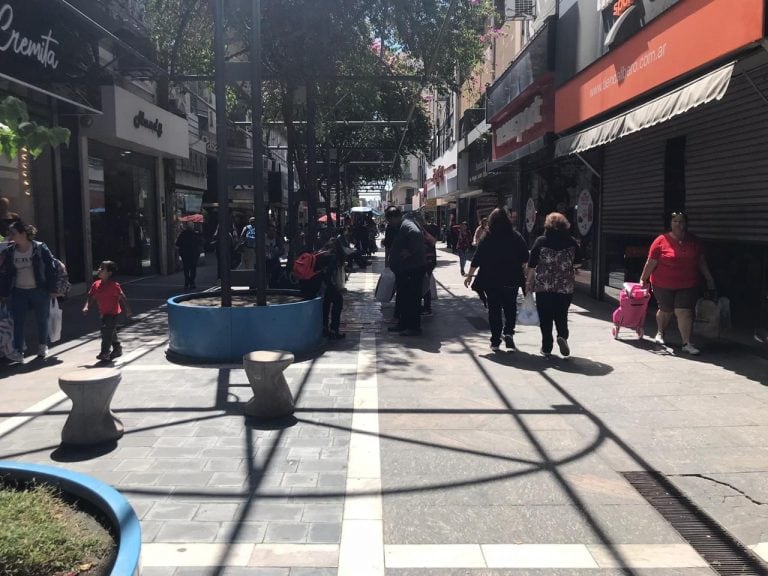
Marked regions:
[141,544,708,576]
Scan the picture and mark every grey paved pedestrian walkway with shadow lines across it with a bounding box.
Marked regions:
[0,245,768,576]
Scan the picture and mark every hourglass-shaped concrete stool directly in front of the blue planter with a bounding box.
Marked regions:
[243,350,293,418]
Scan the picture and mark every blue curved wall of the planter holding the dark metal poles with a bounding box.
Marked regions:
[168,290,323,362]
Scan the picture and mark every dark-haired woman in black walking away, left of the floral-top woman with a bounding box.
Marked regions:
[464,208,528,352]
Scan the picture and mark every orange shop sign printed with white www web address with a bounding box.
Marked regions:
[555,0,765,132]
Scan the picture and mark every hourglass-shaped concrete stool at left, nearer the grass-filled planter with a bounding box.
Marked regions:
[59,368,123,444]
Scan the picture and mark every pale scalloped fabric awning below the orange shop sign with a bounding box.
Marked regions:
[555,62,736,158]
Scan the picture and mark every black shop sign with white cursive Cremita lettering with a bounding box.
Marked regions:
[0,0,101,111]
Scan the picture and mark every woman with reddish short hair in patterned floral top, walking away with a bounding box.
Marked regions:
[526,212,581,357]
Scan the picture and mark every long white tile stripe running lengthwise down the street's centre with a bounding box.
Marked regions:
[338,273,384,576]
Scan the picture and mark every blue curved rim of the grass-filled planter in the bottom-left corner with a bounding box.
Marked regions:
[0,460,141,576]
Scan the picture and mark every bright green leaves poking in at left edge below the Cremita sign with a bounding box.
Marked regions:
[0,96,69,159]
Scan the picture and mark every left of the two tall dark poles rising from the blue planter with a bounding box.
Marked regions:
[214,0,232,308]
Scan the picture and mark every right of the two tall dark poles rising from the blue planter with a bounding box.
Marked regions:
[251,0,267,306]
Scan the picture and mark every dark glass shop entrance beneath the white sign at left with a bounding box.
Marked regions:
[88,143,158,276]
